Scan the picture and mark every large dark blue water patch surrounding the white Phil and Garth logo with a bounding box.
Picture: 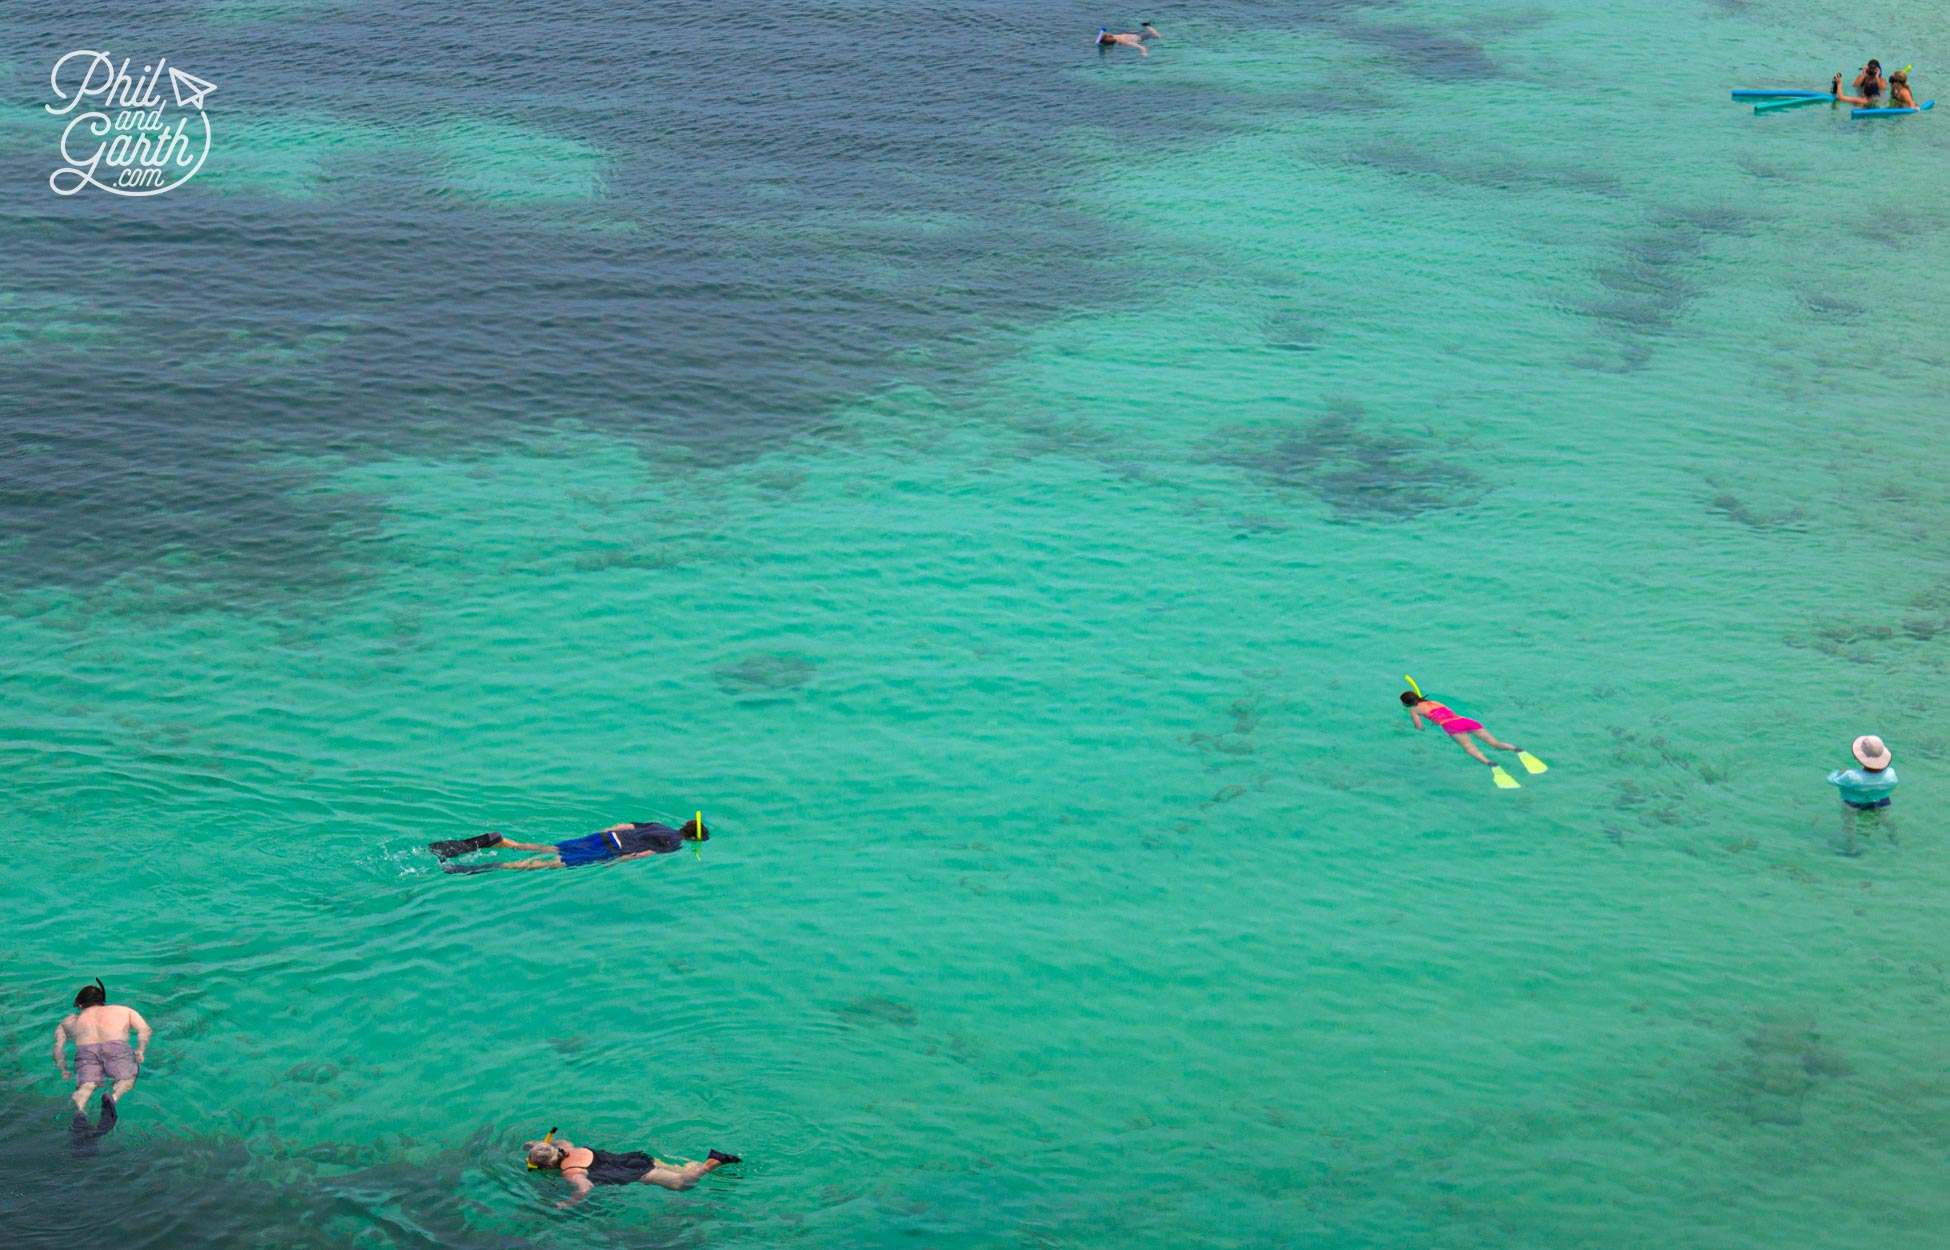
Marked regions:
[0,0,1404,593]
